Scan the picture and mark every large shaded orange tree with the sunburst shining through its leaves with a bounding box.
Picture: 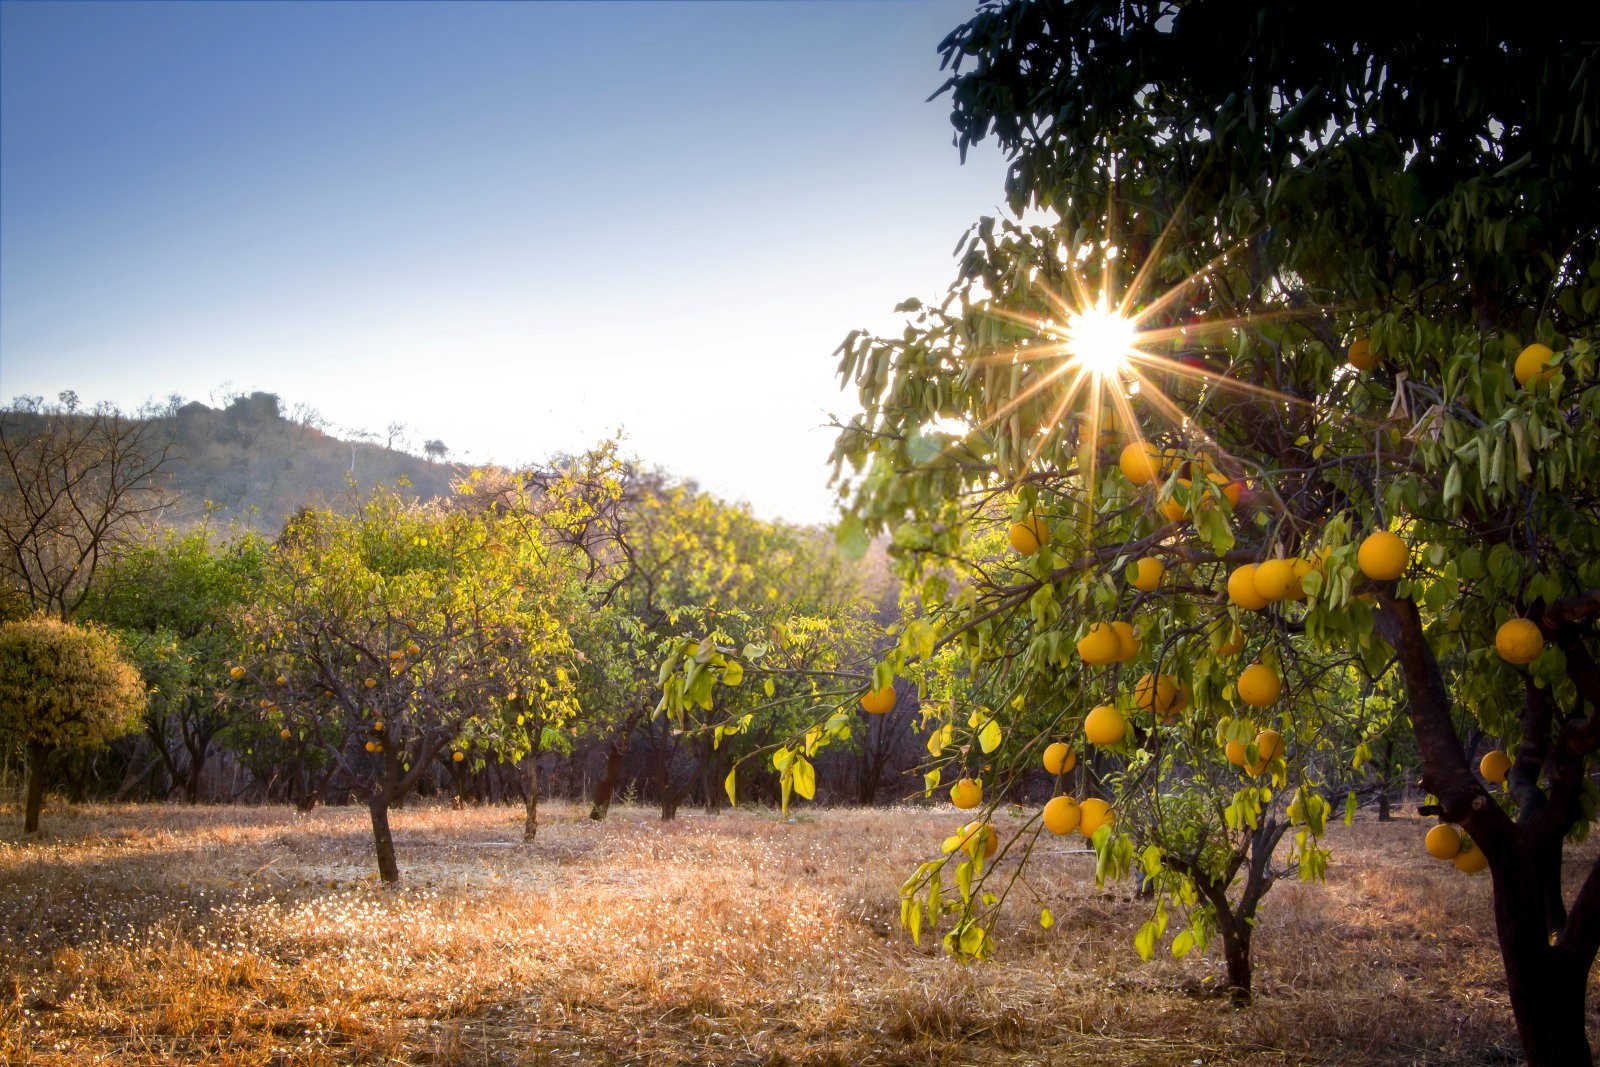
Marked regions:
[819,0,1600,1064]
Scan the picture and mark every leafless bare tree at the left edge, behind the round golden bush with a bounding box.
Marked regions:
[0,394,171,619]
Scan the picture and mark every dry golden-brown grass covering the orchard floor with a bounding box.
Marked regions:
[0,805,1592,1067]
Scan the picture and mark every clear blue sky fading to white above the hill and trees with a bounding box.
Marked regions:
[0,0,1003,522]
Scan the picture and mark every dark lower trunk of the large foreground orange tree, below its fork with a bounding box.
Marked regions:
[1491,856,1594,1067]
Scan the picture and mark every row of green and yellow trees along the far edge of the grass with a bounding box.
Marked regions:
[0,410,934,880]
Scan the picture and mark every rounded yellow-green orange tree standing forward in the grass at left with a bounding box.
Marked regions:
[229,490,566,881]
